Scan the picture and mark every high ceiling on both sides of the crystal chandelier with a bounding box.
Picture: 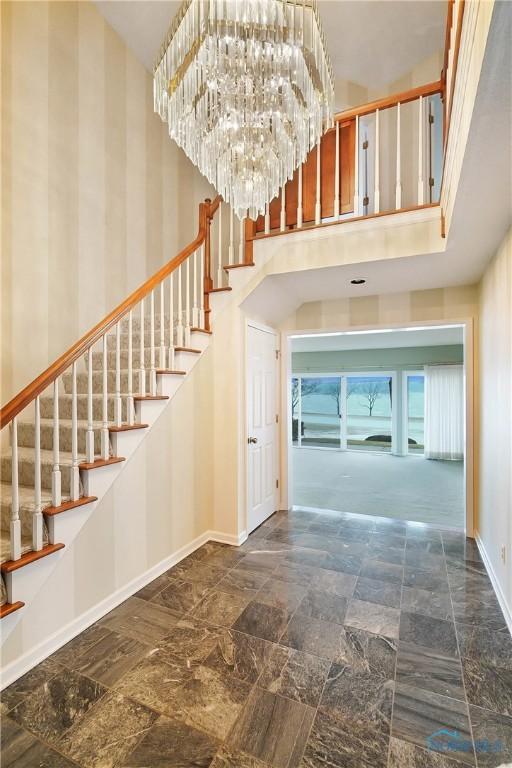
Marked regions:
[96,0,446,89]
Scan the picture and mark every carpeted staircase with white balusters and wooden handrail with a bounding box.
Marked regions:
[0,198,252,634]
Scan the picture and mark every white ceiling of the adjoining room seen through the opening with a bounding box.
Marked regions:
[292,326,463,352]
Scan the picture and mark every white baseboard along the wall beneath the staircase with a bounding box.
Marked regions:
[0,531,247,690]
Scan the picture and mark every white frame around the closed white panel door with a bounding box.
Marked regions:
[242,318,283,532]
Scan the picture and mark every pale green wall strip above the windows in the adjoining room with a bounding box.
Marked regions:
[292,344,464,373]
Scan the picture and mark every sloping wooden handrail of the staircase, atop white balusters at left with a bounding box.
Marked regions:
[0,196,221,429]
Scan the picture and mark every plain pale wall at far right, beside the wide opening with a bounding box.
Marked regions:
[478,229,512,617]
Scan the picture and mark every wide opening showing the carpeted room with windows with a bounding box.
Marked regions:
[288,325,471,529]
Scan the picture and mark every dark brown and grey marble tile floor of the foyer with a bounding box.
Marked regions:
[0,510,512,768]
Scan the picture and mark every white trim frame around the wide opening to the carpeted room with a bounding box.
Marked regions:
[280,317,478,538]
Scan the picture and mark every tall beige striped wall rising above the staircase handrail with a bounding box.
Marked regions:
[0,2,209,404]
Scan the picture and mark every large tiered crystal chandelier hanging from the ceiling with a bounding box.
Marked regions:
[154,0,334,219]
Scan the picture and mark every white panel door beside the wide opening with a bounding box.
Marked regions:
[247,325,278,533]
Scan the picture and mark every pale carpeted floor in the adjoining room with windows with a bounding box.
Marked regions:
[292,448,464,529]
